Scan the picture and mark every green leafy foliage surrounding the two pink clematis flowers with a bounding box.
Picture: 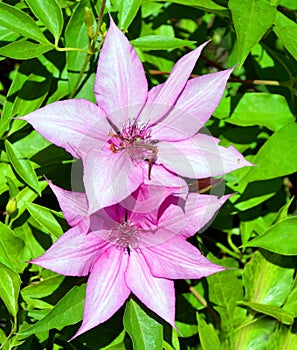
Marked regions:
[0,0,297,350]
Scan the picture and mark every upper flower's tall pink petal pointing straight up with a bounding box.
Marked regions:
[95,17,148,127]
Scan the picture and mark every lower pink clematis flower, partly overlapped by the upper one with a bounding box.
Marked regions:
[32,184,229,337]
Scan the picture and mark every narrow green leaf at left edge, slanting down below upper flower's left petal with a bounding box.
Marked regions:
[5,140,41,195]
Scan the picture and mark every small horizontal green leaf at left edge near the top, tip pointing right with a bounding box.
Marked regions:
[0,41,53,60]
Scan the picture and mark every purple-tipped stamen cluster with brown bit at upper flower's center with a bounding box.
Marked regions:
[108,121,158,180]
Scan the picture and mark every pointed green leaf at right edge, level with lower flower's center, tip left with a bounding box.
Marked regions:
[245,217,297,255]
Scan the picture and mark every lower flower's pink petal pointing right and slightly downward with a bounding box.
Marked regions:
[143,236,224,279]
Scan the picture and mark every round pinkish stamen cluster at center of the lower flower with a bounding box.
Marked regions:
[109,220,140,253]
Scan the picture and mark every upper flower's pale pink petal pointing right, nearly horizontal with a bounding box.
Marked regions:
[156,134,251,178]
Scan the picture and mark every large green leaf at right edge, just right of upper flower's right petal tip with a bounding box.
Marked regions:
[241,123,297,182]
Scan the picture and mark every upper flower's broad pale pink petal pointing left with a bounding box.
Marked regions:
[20,99,110,158]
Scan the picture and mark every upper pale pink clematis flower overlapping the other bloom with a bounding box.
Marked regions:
[23,19,250,214]
